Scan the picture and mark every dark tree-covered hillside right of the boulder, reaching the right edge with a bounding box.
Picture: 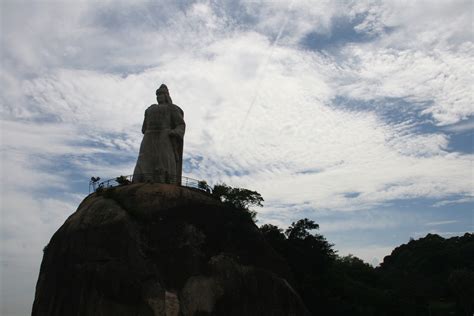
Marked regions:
[260,222,474,316]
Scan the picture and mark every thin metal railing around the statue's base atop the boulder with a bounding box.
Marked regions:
[89,172,212,193]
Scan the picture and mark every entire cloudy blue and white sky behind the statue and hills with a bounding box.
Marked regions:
[0,0,474,315]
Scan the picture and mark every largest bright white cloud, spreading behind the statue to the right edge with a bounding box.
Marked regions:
[4,16,472,209]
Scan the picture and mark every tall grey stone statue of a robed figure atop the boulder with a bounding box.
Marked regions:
[133,84,186,185]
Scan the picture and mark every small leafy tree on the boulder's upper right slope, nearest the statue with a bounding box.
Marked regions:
[212,183,264,222]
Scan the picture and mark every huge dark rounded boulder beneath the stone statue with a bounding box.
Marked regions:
[32,183,308,316]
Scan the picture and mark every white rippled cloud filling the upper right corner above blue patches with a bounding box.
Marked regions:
[336,1,474,125]
